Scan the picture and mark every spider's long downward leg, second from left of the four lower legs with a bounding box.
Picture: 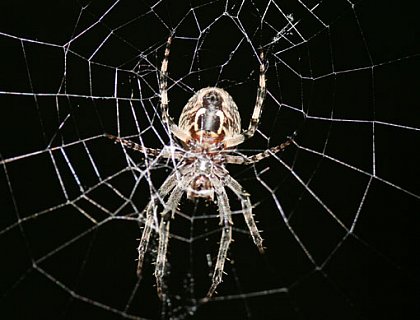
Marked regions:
[155,177,191,300]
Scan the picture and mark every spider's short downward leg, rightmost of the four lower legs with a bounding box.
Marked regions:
[225,175,264,253]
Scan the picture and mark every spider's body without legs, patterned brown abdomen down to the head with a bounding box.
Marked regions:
[179,87,241,201]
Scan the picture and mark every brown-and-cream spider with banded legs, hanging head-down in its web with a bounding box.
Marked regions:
[106,36,293,300]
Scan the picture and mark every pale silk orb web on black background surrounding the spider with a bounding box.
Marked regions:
[0,0,420,319]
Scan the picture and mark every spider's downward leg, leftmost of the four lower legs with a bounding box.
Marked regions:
[137,172,177,277]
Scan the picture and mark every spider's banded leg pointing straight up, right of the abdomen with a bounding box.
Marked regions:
[223,51,267,148]
